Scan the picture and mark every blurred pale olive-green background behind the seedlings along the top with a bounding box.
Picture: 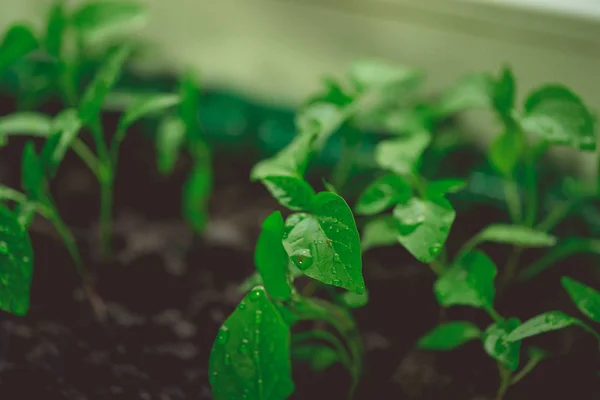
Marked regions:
[0,0,600,175]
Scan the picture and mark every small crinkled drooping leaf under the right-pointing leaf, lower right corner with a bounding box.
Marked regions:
[483,318,521,371]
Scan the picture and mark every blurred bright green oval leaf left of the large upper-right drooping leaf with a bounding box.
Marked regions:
[488,129,525,177]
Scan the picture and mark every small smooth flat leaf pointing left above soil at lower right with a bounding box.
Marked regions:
[418,321,481,350]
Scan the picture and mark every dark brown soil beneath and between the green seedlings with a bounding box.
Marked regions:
[0,104,600,400]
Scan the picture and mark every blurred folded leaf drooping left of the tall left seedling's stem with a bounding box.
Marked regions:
[42,108,82,176]
